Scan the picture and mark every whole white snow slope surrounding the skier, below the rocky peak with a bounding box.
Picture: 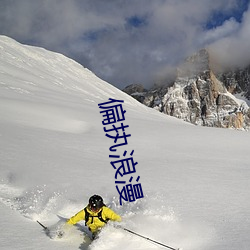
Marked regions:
[0,36,250,250]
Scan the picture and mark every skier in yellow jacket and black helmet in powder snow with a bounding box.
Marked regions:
[67,194,122,239]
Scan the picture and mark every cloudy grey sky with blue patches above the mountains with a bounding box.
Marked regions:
[0,0,250,88]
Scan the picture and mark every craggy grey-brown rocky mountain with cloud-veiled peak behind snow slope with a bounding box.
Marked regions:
[123,50,250,129]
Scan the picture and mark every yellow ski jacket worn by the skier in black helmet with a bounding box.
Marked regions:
[67,206,122,233]
